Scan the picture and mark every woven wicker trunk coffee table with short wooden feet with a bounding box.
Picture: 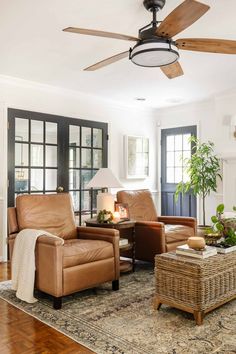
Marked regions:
[154,252,236,325]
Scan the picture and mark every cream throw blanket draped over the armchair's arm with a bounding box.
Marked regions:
[11,229,61,303]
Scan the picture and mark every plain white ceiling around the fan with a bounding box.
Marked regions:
[0,0,236,107]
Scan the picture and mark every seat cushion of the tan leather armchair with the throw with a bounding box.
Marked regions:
[63,239,114,268]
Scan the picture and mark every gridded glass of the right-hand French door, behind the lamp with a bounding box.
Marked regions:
[68,125,106,223]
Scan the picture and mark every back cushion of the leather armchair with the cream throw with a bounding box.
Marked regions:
[16,193,77,239]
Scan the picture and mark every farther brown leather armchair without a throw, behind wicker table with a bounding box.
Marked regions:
[117,189,196,262]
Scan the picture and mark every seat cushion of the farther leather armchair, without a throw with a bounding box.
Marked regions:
[165,224,194,243]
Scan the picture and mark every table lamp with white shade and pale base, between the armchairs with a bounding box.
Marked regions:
[87,168,123,213]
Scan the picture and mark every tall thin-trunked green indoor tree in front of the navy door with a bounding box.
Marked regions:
[175,137,222,228]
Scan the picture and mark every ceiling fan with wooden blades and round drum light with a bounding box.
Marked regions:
[63,0,236,79]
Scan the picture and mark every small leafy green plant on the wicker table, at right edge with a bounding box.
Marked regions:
[206,204,236,253]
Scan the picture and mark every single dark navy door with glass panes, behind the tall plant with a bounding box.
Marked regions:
[161,126,197,217]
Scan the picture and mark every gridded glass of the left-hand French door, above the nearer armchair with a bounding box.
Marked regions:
[9,110,58,204]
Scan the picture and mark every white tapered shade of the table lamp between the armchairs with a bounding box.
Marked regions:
[87,168,123,188]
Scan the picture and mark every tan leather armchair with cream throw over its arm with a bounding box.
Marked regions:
[8,193,120,309]
